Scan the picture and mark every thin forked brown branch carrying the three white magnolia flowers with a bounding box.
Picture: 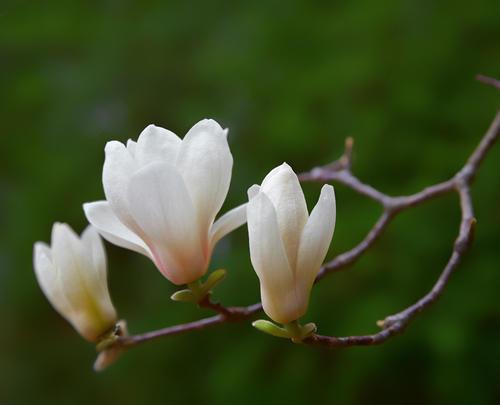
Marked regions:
[117,109,500,347]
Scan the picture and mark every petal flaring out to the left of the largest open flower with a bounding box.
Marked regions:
[83,201,152,258]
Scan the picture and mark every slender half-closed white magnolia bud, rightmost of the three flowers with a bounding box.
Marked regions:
[247,163,336,324]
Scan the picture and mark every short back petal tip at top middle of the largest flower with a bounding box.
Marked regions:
[135,125,181,167]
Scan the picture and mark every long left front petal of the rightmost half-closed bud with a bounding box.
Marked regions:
[247,193,297,323]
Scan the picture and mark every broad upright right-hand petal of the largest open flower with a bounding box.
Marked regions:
[176,120,233,233]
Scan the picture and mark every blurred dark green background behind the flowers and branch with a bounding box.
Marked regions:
[0,0,500,405]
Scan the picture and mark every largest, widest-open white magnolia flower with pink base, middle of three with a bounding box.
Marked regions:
[84,120,246,285]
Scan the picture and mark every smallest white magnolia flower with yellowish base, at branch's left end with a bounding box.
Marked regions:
[33,223,117,342]
